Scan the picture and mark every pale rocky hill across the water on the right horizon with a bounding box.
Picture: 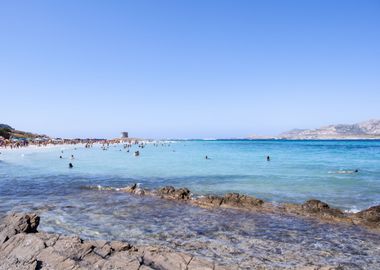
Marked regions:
[278,120,380,139]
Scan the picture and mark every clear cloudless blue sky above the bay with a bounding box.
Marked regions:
[0,0,380,138]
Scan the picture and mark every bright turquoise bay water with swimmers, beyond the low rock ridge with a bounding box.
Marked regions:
[0,140,380,211]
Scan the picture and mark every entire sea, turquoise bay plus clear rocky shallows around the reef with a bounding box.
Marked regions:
[0,140,380,269]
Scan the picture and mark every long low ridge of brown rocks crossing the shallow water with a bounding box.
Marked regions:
[87,184,380,233]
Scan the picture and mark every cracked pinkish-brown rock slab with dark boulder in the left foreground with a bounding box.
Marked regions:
[0,213,229,270]
